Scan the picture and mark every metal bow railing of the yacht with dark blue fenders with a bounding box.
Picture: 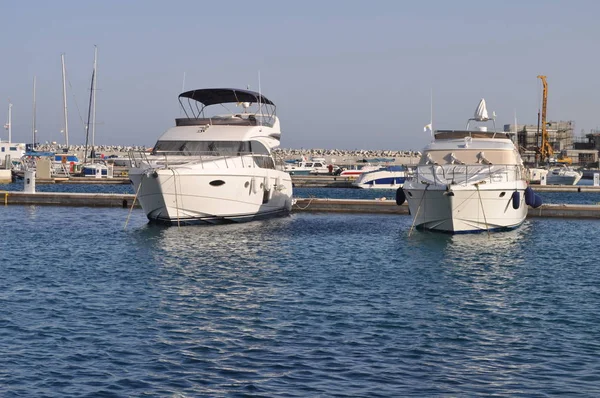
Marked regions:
[413,164,526,186]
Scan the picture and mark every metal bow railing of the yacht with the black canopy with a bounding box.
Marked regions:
[129,151,276,169]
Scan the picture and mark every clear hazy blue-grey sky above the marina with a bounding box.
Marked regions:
[0,0,600,150]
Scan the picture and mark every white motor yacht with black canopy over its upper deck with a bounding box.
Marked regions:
[129,88,292,225]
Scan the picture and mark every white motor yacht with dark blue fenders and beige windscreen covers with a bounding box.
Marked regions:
[396,99,541,233]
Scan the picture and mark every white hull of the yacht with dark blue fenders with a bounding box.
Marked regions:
[404,181,527,233]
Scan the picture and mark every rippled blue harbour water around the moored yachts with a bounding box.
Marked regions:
[0,186,600,397]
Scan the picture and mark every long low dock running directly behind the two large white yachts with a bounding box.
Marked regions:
[0,191,600,219]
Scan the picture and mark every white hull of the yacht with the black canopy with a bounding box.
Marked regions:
[130,161,292,224]
